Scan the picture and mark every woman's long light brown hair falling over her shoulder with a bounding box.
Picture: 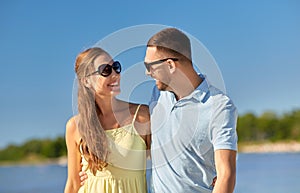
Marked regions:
[75,47,109,175]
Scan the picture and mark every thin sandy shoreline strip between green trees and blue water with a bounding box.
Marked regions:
[0,141,300,167]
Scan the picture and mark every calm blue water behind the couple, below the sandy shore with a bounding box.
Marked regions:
[0,154,300,193]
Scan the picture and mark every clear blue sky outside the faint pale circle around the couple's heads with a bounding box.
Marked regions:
[0,0,300,148]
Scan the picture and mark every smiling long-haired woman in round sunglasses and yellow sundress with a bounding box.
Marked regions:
[65,48,151,193]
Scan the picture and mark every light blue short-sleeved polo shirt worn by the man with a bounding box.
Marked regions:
[149,75,237,193]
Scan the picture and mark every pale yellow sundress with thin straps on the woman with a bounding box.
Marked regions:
[78,106,147,193]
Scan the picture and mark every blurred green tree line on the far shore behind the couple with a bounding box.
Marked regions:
[0,110,300,161]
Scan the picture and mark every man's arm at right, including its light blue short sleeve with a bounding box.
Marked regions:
[211,95,238,193]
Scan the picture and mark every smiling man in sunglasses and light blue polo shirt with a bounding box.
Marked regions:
[145,28,237,193]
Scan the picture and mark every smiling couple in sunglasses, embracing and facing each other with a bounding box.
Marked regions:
[65,28,237,193]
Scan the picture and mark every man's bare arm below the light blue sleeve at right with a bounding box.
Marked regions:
[213,149,236,193]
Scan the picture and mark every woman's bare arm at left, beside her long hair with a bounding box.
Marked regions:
[65,117,81,193]
